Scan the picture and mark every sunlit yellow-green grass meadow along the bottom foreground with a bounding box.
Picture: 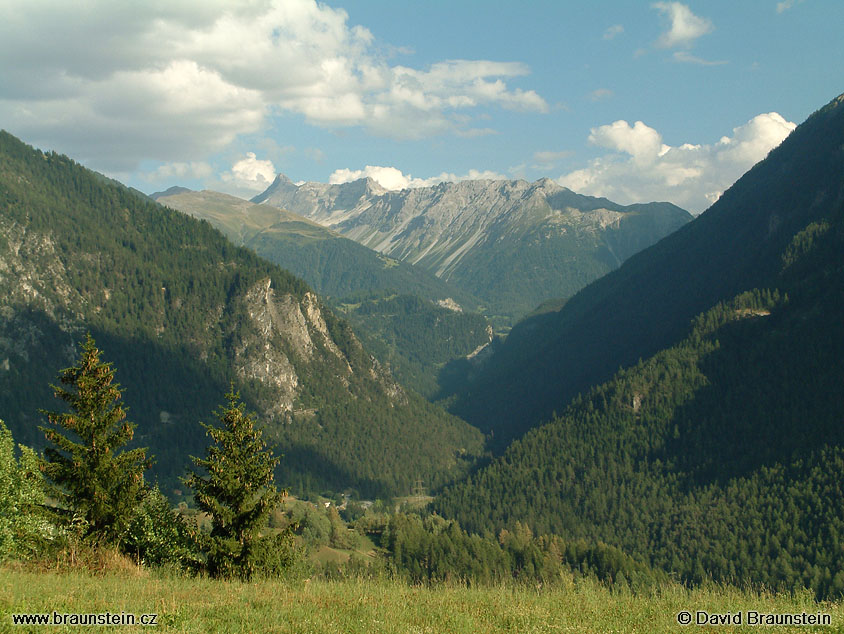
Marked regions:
[0,567,844,634]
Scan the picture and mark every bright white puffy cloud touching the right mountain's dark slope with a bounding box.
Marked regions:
[559,112,796,213]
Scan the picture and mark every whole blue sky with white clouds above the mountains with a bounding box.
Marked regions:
[0,0,844,213]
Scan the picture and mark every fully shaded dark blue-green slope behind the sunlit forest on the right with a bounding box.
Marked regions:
[452,92,844,446]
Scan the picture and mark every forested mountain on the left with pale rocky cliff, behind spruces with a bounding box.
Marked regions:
[0,132,481,495]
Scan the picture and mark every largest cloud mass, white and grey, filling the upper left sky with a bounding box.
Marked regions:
[0,0,548,169]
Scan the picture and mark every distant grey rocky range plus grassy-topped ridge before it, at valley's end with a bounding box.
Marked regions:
[152,175,689,398]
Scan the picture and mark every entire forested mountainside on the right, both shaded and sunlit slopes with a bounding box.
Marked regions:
[436,96,844,596]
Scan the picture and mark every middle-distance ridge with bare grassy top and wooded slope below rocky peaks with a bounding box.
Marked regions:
[153,188,491,397]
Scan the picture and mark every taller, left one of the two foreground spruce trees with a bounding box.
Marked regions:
[39,333,150,545]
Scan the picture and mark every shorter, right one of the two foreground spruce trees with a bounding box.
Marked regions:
[187,388,287,579]
